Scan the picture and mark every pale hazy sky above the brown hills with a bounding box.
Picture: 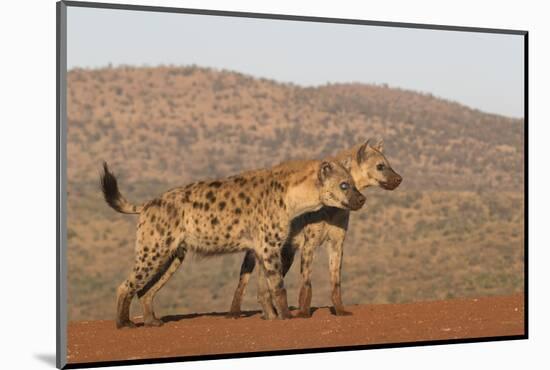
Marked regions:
[67,7,524,117]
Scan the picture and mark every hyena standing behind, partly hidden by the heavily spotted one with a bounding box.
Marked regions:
[226,141,402,319]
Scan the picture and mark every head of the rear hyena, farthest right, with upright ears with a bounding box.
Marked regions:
[355,140,403,190]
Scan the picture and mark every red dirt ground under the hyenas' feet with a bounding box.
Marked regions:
[67,294,524,364]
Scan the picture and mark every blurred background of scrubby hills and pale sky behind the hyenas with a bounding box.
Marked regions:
[67,7,524,320]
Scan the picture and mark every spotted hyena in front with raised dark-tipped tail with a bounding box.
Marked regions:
[101,161,365,328]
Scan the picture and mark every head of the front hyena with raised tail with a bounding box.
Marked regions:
[318,162,366,211]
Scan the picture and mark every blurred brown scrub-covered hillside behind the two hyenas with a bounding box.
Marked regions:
[67,67,524,320]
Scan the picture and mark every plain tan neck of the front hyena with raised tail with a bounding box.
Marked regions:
[285,167,323,219]
